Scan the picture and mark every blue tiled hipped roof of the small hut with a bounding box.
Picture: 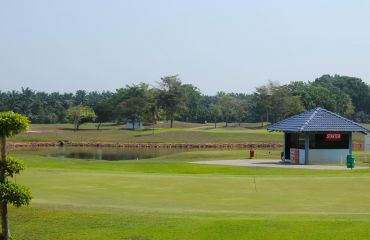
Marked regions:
[267,107,370,134]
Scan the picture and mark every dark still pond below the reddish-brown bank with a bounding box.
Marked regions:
[44,147,189,161]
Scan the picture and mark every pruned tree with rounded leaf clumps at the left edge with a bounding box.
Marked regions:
[0,112,31,240]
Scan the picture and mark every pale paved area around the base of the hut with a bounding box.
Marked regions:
[191,159,369,170]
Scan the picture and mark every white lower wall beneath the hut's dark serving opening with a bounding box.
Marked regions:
[309,149,349,164]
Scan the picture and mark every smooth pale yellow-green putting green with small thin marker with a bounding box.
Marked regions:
[17,169,370,214]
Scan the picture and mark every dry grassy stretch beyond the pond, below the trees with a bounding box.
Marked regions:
[11,122,364,143]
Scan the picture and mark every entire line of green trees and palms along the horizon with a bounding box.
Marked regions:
[0,75,370,129]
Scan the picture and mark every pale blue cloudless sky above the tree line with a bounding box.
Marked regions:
[0,0,370,94]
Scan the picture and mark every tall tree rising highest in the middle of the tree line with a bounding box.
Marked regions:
[157,75,185,128]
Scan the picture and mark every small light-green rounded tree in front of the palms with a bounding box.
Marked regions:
[66,105,96,131]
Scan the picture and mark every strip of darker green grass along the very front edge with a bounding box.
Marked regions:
[13,209,369,240]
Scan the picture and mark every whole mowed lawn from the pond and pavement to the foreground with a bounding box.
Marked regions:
[10,149,370,240]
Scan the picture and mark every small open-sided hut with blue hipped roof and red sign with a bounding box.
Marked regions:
[267,107,369,164]
